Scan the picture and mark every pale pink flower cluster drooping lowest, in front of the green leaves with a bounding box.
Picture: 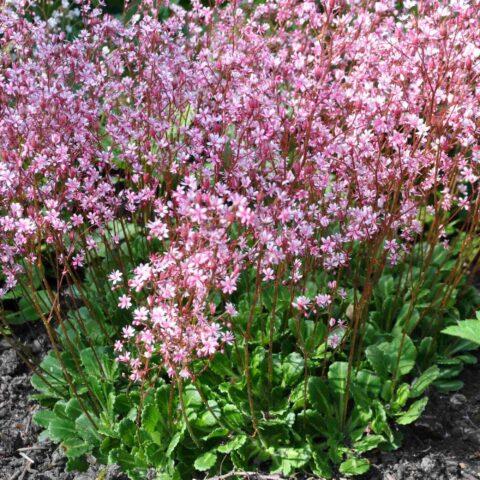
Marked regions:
[109,177,244,380]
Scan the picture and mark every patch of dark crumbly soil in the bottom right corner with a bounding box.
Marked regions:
[365,356,480,480]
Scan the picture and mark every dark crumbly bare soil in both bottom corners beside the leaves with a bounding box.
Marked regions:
[0,326,480,480]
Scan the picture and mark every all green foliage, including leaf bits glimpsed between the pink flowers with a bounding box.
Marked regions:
[0,0,480,480]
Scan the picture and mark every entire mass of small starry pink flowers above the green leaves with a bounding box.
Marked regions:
[0,0,480,377]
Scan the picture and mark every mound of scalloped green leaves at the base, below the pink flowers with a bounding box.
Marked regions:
[27,232,478,480]
